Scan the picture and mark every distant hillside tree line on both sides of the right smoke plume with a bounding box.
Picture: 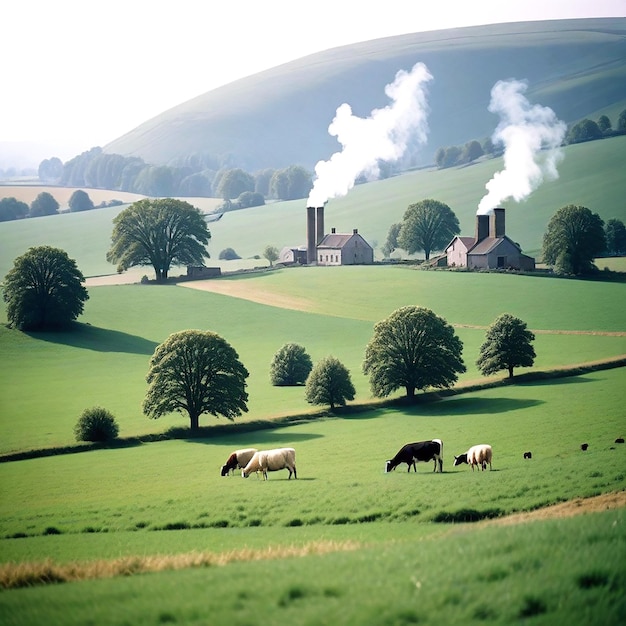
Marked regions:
[435,109,626,169]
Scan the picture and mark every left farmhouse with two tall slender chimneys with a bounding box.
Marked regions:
[278,207,374,265]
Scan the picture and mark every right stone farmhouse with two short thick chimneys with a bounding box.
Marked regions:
[445,208,535,270]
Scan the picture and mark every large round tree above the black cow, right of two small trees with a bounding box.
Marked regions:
[363,306,465,399]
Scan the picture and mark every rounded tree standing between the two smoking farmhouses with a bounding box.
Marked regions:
[398,200,461,261]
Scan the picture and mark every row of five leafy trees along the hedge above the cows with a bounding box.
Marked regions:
[133,306,536,430]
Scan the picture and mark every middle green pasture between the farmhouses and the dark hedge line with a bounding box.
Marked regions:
[0,266,626,453]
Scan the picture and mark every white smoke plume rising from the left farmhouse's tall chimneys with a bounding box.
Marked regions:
[307,63,432,207]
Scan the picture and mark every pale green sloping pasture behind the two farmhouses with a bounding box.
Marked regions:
[0,136,626,279]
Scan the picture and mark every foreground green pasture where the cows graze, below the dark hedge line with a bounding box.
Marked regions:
[0,369,626,625]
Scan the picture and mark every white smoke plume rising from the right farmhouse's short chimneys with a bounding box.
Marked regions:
[478,80,566,214]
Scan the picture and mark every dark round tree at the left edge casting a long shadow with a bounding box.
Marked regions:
[3,246,89,330]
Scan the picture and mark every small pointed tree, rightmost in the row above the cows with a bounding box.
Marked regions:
[476,313,537,378]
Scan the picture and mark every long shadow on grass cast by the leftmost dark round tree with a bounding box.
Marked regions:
[26,323,158,356]
